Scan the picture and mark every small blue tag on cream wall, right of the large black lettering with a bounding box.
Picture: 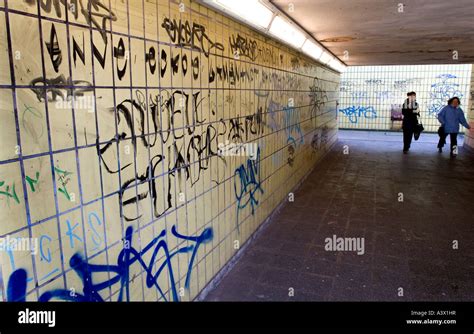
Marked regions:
[234,148,263,230]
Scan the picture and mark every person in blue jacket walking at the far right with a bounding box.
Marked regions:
[438,96,471,156]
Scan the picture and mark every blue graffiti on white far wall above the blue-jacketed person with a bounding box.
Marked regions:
[428,74,463,116]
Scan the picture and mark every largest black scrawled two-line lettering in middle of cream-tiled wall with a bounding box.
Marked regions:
[97,90,227,221]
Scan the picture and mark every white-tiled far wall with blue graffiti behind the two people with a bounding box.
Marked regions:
[338,65,471,132]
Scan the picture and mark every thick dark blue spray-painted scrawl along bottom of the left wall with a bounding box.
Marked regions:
[7,226,213,302]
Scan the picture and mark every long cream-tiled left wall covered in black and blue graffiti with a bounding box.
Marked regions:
[0,0,340,301]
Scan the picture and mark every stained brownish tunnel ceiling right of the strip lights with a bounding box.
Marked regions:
[271,0,474,65]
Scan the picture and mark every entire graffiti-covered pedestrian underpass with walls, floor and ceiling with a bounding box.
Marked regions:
[0,0,474,302]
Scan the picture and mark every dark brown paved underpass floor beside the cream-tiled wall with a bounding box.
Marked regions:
[206,131,474,301]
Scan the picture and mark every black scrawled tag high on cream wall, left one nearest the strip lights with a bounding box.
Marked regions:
[161,18,224,57]
